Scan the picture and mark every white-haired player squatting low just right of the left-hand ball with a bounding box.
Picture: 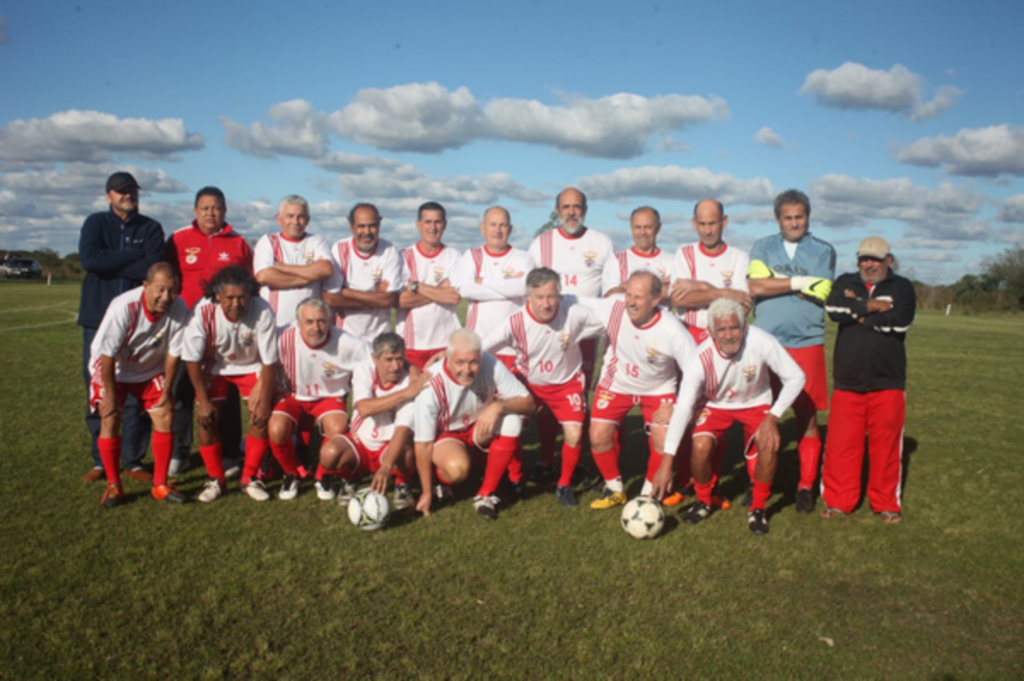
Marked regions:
[415,329,536,520]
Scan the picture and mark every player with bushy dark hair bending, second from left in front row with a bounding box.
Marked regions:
[181,266,278,502]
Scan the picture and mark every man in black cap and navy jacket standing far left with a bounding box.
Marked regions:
[78,172,164,482]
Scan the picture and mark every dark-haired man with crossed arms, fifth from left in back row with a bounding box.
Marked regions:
[395,202,461,369]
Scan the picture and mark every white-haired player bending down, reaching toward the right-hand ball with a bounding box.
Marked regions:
[652,298,805,535]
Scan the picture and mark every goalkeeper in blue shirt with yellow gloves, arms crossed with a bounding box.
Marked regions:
[748,189,836,513]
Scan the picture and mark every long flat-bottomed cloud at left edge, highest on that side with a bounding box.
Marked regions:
[0,110,204,168]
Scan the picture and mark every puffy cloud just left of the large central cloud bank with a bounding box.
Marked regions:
[220,99,330,159]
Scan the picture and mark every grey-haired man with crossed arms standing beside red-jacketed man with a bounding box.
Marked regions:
[253,194,334,329]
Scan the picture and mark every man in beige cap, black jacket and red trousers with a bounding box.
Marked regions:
[821,237,916,522]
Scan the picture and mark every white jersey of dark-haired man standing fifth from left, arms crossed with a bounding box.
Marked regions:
[395,244,461,350]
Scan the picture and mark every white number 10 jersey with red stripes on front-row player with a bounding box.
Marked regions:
[482,296,604,385]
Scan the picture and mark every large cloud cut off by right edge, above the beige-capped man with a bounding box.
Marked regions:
[895,124,1024,177]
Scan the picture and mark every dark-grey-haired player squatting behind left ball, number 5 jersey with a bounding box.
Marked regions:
[331,332,428,511]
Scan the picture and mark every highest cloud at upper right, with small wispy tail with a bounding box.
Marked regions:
[800,61,963,122]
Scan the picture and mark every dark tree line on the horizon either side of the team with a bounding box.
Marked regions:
[0,244,1024,314]
